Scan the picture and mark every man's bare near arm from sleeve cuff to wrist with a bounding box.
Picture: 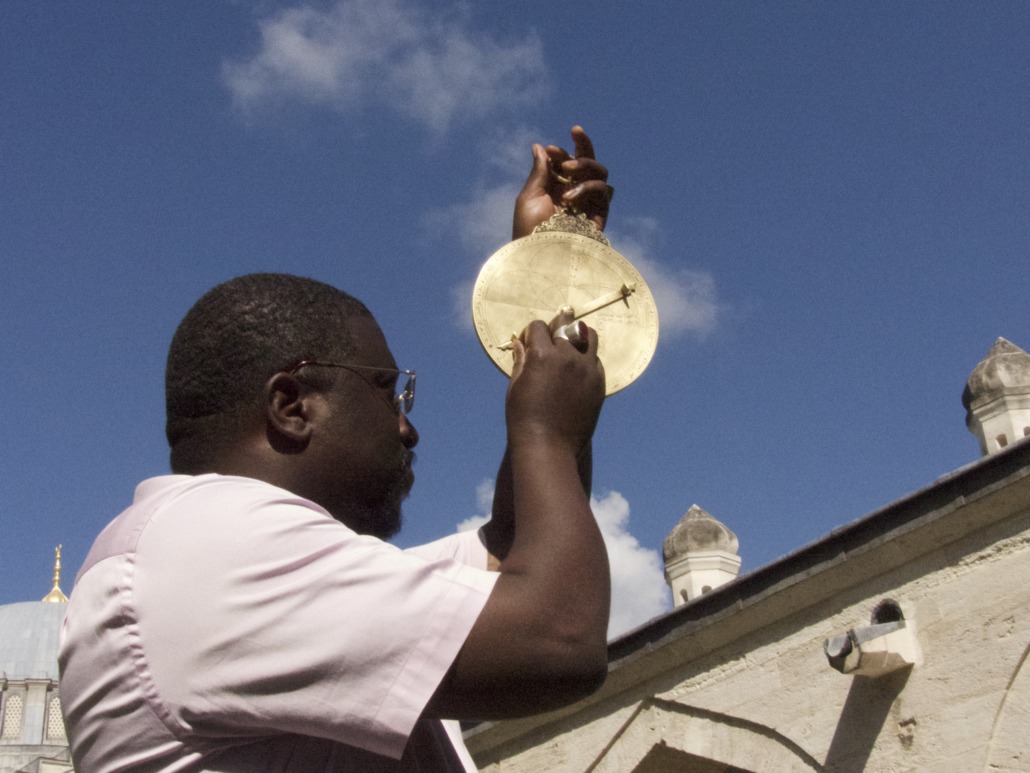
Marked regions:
[430,443,611,719]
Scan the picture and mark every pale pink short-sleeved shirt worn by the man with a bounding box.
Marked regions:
[59,475,497,773]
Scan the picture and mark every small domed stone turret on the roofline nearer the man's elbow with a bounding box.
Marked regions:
[661,505,741,606]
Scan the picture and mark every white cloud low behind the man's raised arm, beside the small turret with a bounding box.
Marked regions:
[457,480,672,639]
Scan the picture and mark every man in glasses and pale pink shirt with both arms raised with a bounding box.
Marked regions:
[60,127,611,773]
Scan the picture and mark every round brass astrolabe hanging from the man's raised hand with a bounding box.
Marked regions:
[472,211,658,395]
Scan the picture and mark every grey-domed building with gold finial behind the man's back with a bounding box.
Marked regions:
[0,547,72,773]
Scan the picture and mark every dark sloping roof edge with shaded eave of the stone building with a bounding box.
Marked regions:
[466,438,1030,754]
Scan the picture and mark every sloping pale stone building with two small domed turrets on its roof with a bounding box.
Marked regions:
[467,339,1030,773]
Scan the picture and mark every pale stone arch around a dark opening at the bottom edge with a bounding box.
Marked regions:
[587,700,822,773]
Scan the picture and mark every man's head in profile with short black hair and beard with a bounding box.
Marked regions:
[166,274,418,537]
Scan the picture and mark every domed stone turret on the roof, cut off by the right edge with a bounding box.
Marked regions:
[962,338,1030,456]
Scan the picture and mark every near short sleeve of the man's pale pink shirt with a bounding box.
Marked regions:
[132,478,496,758]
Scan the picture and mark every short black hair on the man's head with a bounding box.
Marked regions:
[165,273,372,453]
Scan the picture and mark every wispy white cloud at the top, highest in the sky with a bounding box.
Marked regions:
[222,0,547,134]
